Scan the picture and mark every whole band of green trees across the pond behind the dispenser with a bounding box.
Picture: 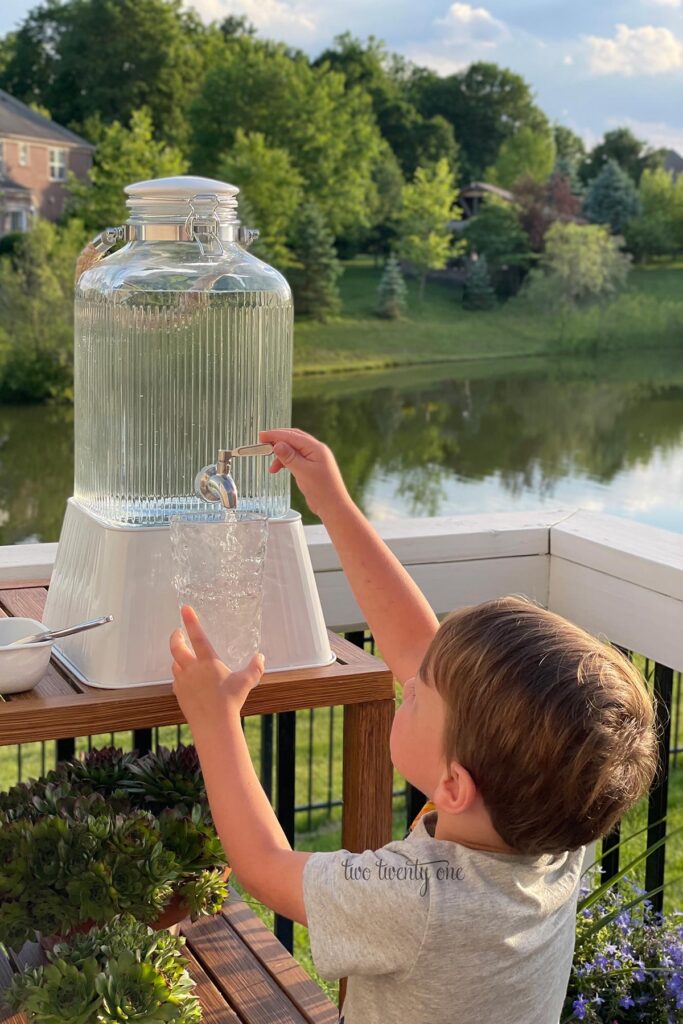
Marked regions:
[0,0,683,393]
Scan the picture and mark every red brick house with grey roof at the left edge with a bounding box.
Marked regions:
[0,89,94,237]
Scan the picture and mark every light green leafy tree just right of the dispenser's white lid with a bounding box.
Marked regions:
[218,128,304,265]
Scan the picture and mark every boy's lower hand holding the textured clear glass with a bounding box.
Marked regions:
[171,605,263,728]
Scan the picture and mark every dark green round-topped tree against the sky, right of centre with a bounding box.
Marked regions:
[409,61,548,181]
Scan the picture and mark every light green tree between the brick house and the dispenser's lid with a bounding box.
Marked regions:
[68,110,187,230]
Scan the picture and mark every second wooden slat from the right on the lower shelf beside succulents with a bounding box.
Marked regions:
[181,914,310,1024]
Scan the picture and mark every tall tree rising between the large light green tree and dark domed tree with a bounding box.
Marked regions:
[315,32,458,177]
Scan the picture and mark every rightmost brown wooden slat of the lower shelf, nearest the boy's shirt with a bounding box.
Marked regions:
[222,890,339,1024]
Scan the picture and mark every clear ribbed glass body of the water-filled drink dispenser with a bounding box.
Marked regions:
[74,243,292,525]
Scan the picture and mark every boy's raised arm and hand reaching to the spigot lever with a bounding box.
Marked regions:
[260,429,438,683]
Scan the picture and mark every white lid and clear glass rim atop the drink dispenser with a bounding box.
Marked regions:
[124,174,240,222]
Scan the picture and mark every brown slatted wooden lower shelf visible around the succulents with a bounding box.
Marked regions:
[0,891,339,1024]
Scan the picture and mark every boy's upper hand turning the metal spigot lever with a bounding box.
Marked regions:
[259,428,350,519]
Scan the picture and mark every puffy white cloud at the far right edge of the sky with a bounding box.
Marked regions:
[585,25,683,76]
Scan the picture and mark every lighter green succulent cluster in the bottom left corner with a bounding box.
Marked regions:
[5,914,202,1024]
